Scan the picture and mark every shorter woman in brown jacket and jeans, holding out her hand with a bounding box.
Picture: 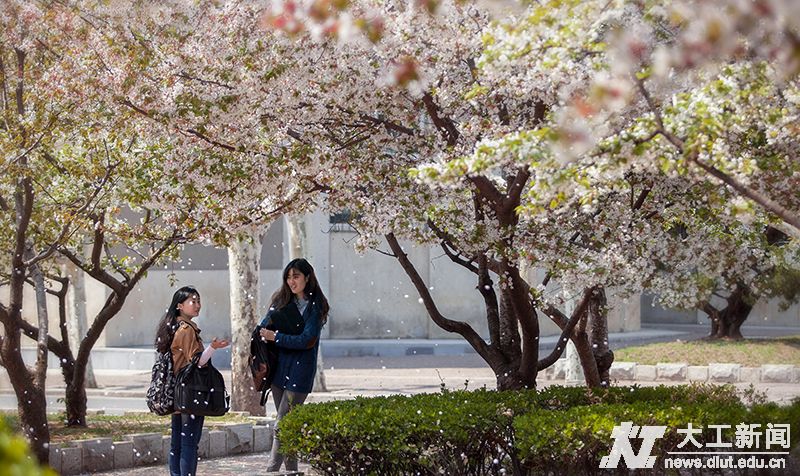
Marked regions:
[156,286,228,476]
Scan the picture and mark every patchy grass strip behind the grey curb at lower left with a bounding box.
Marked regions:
[0,412,253,446]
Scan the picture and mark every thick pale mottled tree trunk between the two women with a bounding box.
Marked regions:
[228,229,265,415]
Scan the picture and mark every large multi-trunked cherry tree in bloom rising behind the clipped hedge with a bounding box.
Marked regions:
[258,1,796,387]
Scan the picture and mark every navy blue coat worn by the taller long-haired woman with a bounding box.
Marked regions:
[261,301,322,393]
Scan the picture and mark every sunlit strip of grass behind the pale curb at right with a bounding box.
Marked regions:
[614,335,800,367]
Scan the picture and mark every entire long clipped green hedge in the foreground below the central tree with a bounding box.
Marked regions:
[279,384,800,475]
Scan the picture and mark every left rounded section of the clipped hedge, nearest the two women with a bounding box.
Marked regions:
[279,390,536,475]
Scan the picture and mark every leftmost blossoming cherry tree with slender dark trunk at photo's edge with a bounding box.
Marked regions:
[0,2,136,461]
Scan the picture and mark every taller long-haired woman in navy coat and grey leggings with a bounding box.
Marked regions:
[261,258,329,471]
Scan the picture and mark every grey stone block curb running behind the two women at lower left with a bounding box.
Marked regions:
[50,418,282,476]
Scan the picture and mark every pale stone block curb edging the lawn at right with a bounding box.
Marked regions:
[540,359,800,383]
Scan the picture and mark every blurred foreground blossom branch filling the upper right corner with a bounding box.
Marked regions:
[478,0,800,236]
